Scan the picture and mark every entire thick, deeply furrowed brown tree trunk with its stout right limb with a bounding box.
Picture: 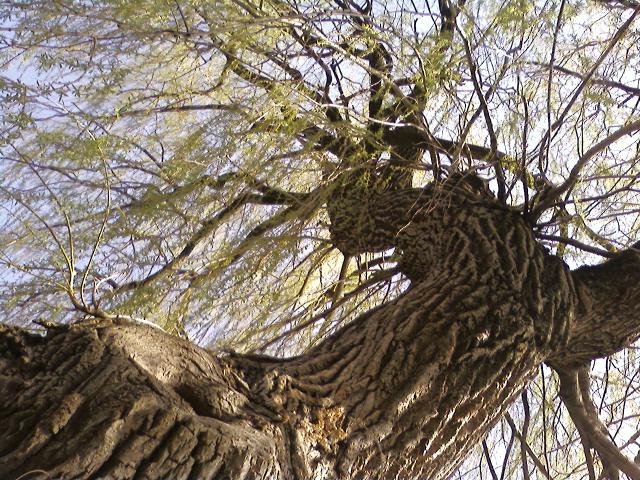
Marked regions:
[0,185,640,479]
